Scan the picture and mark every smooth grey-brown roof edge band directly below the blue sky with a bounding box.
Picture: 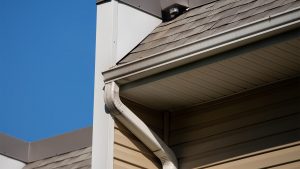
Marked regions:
[0,127,93,163]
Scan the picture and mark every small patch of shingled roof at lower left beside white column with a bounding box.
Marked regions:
[23,147,92,169]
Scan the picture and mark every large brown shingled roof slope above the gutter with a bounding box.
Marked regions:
[118,0,300,65]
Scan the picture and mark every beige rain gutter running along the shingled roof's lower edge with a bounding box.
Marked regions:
[102,7,300,85]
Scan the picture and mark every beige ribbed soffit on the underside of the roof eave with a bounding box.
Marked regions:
[121,31,300,111]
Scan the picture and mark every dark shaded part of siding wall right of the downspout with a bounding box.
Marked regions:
[169,79,300,169]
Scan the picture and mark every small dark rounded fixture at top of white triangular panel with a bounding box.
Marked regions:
[162,4,188,22]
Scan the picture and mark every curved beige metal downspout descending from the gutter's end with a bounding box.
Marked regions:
[104,82,178,169]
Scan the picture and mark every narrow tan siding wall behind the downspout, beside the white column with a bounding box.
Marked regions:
[114,99,163,169]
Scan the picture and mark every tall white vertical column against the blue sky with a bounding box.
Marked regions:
[92,0,118,169]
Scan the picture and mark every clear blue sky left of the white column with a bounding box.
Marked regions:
[0,0,96,141]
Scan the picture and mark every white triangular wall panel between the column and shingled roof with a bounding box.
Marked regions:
[116,3,162,62]
